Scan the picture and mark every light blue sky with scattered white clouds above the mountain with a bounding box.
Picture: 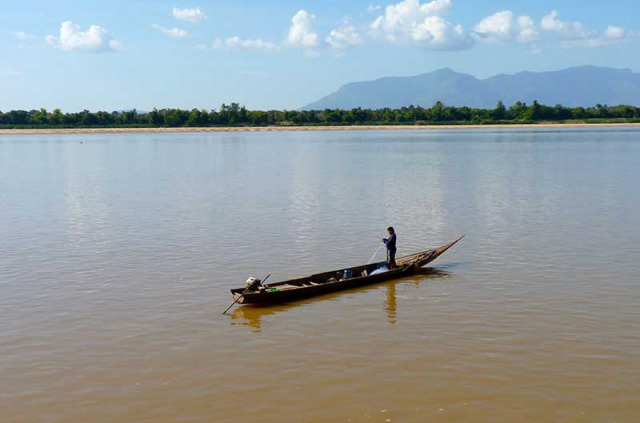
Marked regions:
[0,0,640,111]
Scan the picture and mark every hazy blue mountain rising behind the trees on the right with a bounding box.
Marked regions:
[302,66,640,110]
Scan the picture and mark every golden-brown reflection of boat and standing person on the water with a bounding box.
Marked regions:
[231,267,450,332]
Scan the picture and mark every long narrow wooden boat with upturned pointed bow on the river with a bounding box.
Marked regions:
[231,235,464,304]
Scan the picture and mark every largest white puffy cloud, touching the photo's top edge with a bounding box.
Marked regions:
[371,0,473,50]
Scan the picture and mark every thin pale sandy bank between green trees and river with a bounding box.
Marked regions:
[0,123,640,135]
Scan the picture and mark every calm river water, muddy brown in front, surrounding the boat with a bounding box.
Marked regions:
[0,128,640,423]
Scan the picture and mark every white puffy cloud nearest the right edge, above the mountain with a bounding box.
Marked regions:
[541,10,637,48]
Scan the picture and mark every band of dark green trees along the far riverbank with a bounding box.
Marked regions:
[0,101,640,129]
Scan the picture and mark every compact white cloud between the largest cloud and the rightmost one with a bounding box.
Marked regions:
[473,10,538,44]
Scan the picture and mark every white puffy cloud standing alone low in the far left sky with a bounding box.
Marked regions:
[46,21,121,53]
